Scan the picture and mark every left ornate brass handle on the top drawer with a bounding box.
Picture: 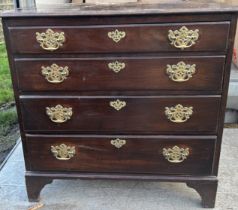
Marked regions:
[36,29,65,51]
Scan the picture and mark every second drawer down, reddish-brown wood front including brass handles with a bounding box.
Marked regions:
[15,56,225,91]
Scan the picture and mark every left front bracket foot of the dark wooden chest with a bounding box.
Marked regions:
[25,176,53,202]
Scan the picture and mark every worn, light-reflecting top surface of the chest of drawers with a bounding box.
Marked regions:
[2,0,238,17]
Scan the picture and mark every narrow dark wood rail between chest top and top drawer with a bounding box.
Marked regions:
[3,13,233,26]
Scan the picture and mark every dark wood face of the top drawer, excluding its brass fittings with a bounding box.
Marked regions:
[9,22,230,54]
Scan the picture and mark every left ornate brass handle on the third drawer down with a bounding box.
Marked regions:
[46,105,73,123]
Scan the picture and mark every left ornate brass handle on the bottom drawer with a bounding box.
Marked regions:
[51,144,76,160]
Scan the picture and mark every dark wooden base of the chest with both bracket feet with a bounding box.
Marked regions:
[26,171,217,205]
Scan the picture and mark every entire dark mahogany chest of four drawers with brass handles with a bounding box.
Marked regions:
[3,3,237,207]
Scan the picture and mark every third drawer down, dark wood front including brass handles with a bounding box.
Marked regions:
[20,96,220,134]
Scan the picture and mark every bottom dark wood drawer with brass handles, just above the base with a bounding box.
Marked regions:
[26,135,216,175]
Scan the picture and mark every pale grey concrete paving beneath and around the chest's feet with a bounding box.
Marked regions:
[0,129,238,210]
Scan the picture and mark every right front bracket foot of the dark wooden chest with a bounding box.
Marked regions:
[186,180,217,208]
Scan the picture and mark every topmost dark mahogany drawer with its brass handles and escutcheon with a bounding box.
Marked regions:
[9,22,230,53]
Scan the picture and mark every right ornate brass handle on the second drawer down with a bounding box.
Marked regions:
[166,61,196,82]
